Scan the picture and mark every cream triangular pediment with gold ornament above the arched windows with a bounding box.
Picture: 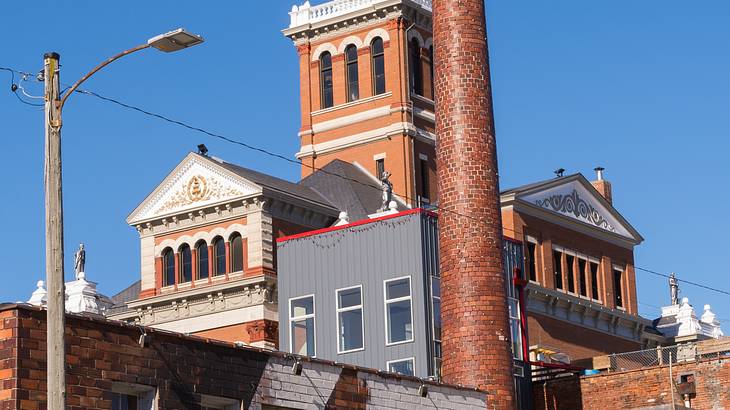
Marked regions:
[128,154,261,224]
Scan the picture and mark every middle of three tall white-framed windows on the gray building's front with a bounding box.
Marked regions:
[335,285,365,354]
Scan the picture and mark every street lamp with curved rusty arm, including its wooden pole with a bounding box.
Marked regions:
[43,28,203,409]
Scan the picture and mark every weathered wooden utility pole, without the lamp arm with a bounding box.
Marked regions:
[43,53,66,409]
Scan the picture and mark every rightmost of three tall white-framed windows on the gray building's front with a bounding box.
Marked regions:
[383,276,413,346]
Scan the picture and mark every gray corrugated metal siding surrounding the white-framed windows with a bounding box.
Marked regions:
[277,213,438,377]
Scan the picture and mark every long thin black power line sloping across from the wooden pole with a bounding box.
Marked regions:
[0,67,730,295]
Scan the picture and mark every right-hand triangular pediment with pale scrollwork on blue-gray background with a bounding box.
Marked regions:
[517,179,635,239]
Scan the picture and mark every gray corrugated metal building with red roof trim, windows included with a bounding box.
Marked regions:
[277,209,440,377]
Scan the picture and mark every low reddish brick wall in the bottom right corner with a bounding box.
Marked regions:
[533,356,730,410]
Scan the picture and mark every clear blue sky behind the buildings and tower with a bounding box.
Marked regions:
[0,0,730,324]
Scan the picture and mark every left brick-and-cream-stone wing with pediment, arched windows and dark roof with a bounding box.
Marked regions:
[109,153,339,348]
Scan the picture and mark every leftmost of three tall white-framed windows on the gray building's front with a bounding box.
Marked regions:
[289,295,317,356]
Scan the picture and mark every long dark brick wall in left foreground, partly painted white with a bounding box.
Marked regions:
[0,305,486,410]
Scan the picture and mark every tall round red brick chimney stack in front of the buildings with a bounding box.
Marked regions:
[433,0,515,409]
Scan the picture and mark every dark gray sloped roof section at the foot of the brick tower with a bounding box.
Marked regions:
[299,159,390,221]
